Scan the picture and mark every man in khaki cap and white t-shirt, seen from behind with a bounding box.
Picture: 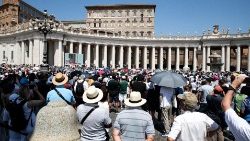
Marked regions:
[167,92,219,141]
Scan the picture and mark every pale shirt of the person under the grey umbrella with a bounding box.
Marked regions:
[160,87,174,107]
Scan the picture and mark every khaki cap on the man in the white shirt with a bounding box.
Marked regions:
[177,92,198,108]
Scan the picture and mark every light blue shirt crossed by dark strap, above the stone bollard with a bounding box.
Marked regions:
[46,86,75,104]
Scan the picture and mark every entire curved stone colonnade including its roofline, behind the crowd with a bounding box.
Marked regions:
[0,20,250,71]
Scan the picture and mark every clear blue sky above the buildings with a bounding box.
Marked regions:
[14,0,250,35]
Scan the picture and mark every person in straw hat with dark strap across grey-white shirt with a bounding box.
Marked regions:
[77,86,112,141]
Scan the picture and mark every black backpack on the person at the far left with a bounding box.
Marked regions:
[6,97,29,131]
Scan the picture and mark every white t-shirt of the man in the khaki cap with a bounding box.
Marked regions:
[168,111,219,141]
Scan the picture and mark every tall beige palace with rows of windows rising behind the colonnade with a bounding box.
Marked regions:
[86,4,156,37]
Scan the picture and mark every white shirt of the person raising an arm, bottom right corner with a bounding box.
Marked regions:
[225,108,250,141]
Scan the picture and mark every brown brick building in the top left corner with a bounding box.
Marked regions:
[0,0,43,29]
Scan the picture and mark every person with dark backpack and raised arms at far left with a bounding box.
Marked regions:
[3,78,45,141]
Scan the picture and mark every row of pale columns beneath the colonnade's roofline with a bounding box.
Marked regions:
[0,38,250,71]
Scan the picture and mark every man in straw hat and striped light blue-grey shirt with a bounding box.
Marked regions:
[113,91,155,141]
